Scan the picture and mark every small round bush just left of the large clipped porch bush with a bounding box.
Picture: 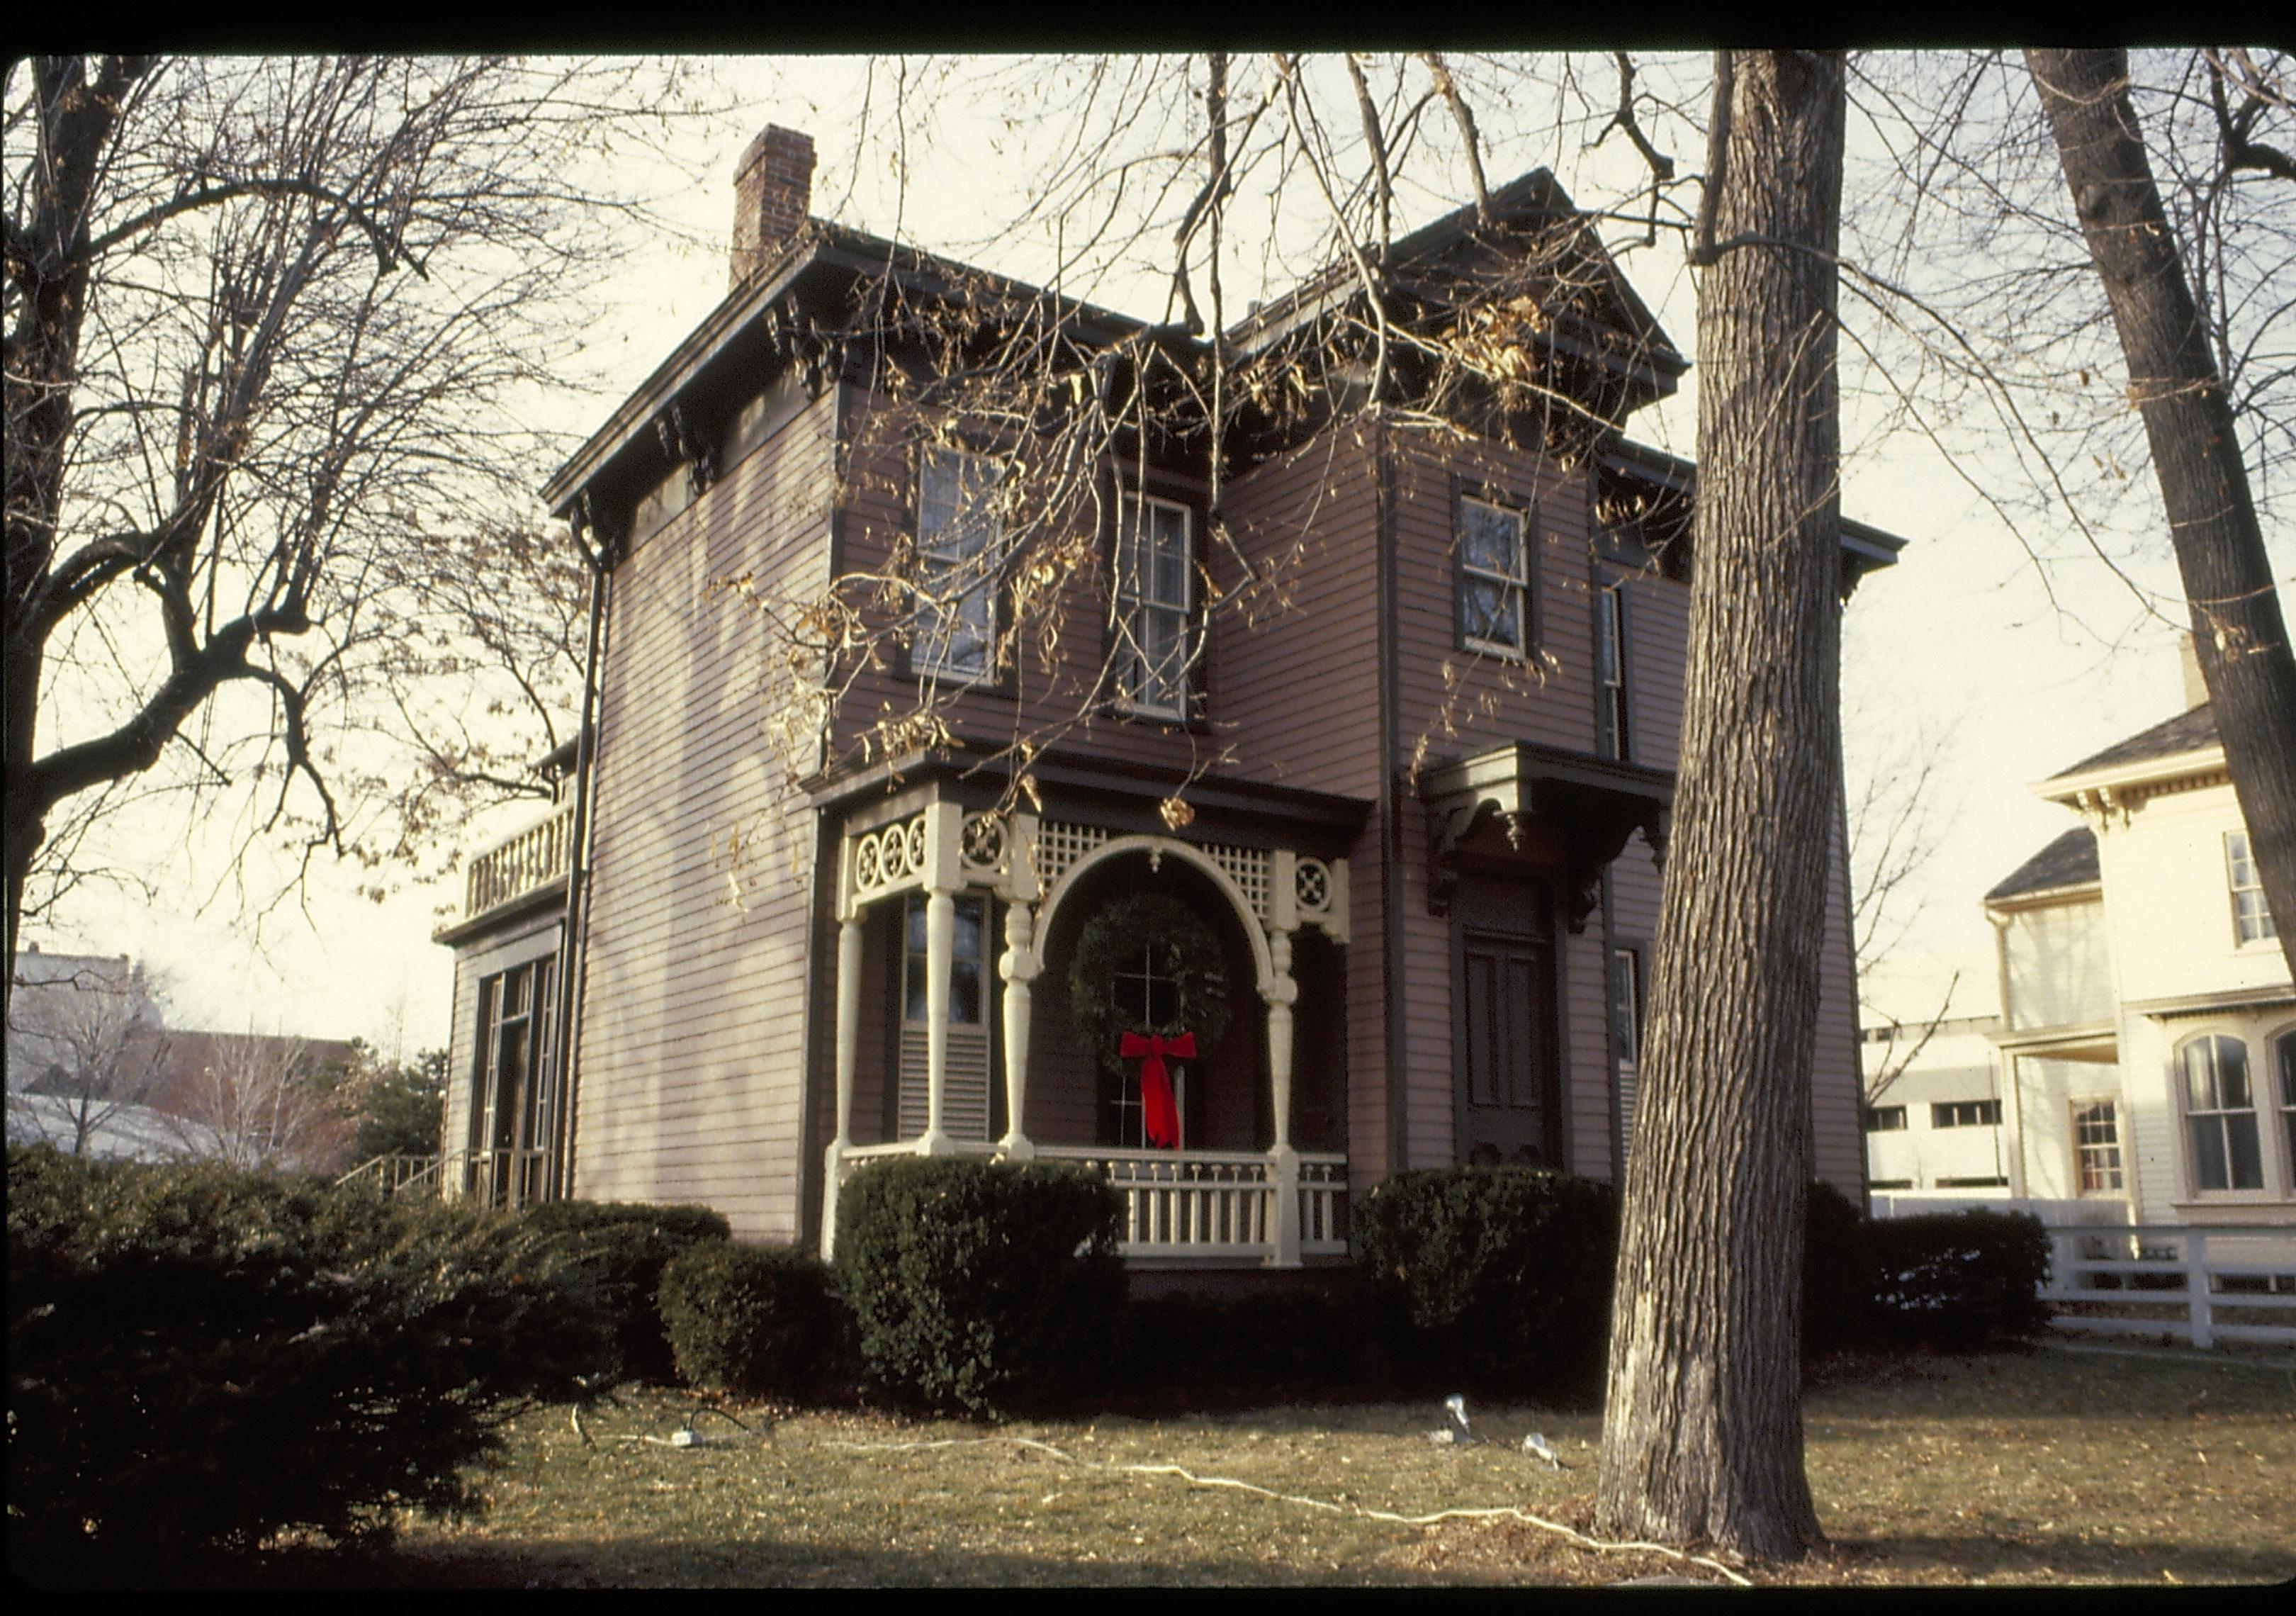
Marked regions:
[659,1240,852,1398]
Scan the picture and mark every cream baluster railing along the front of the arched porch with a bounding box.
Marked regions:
[838,1141,1348,1262]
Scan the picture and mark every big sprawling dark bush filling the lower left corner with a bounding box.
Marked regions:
[7,1145,604,1581]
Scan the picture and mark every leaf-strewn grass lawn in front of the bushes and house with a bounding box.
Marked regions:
[332,1345,2296,1586]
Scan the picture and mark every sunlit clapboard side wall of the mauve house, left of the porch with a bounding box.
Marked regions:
[576,378,833,1240]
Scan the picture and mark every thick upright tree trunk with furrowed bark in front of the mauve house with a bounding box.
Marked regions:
[1596,50,1844,1559]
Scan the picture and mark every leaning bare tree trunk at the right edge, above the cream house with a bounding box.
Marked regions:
[2025,50,2296,973]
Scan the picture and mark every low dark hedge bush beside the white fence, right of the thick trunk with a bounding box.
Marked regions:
[1867,1208,2048,1350]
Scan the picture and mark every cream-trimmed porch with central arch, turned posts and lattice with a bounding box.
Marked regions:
[822,801,1348,1267]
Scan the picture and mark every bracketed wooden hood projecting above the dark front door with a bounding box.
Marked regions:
[1419,741,1674,932]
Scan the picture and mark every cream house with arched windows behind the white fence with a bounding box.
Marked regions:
[1986,650,2296,1225]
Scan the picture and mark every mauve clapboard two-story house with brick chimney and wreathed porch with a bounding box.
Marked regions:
[443,128,1901,1267]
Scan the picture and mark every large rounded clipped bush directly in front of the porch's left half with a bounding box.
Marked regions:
[835,1157,1125,1414]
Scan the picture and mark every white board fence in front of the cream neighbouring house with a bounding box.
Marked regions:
[2041,1223,2296,1347]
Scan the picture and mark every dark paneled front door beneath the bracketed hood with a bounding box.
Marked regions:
[1453,913,1561,1168]
